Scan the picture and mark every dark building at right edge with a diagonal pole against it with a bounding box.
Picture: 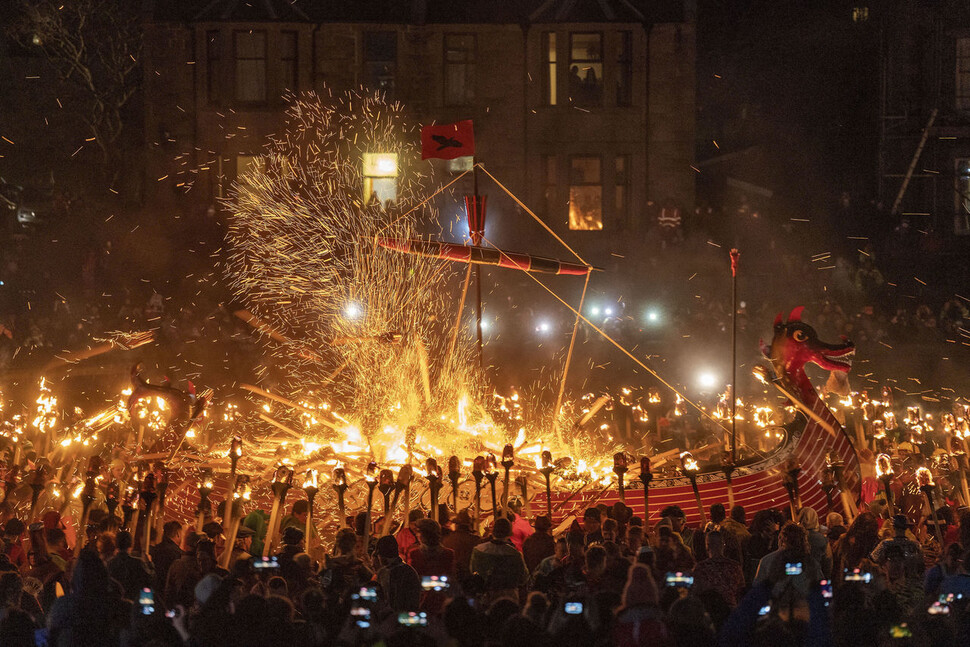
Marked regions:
[876,0,970,239]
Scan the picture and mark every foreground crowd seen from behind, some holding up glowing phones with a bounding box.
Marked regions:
[0,488,970,647]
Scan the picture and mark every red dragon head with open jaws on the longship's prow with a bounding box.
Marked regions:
[762,306,855,381]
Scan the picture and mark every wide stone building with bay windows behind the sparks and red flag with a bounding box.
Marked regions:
[145,0,695,258]
